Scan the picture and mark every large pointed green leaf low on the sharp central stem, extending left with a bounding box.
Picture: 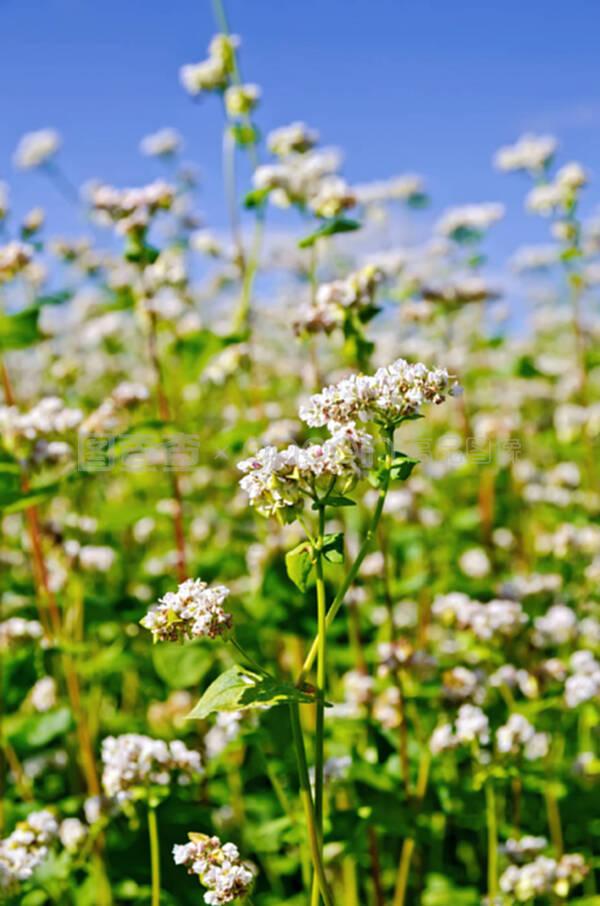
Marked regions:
[187,664,314,720]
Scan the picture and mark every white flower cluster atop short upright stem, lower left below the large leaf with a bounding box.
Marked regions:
[102,733,202,803]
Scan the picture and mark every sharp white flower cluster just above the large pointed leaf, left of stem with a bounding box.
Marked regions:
[140,579,232,642]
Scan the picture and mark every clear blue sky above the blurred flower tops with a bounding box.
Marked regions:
[0,0,600,262]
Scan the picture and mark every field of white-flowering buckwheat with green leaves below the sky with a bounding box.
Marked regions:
[0,4,600,906]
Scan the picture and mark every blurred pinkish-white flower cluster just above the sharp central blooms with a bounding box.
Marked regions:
[294,264,383,333]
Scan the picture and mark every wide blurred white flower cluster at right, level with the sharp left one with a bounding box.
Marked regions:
[432,592,527,641]
